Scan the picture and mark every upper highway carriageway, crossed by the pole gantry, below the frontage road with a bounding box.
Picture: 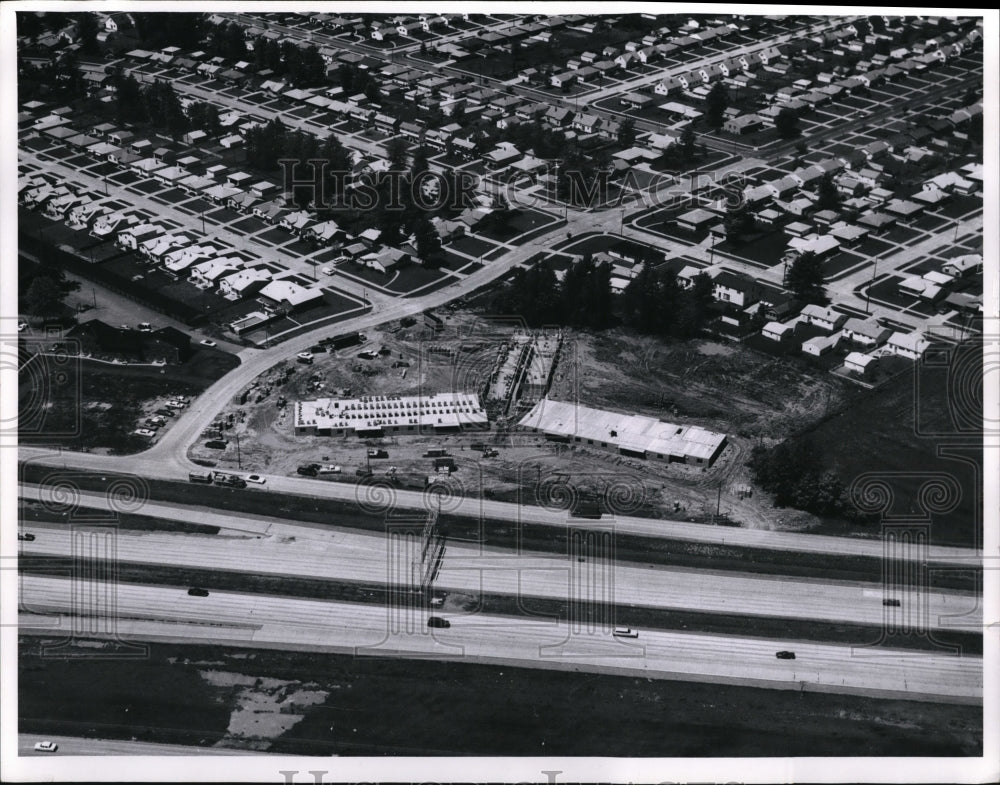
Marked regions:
[20,487,982,632]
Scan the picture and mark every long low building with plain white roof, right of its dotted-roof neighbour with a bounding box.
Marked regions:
[520,398,726,466]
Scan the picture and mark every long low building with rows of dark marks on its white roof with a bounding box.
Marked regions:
[295,392,490,436]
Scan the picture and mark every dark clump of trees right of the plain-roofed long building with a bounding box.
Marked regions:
[747,439,862,519]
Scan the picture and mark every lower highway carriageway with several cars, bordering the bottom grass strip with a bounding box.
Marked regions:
[18,575,983,704]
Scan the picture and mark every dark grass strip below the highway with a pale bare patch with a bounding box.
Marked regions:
[18,637,982,757]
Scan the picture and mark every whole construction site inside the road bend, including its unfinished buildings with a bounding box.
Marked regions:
[184,312,838,528]
